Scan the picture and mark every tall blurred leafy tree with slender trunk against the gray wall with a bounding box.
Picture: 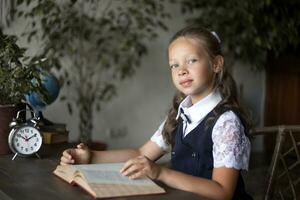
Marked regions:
[6,0,169,142]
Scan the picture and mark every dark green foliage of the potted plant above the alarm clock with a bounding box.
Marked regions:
[0,30,42,105]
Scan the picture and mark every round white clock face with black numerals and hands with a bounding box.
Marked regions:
[12,126,42,155]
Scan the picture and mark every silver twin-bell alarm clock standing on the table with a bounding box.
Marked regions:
[8,109,42,160]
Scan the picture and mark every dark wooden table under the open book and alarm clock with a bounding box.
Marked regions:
[0,144,203,200]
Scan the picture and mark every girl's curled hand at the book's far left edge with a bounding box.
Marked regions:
[60,143,91,165]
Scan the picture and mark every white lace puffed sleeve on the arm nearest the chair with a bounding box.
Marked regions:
[212,111,251,170]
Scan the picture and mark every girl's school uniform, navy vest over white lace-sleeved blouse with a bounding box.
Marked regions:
[151,91,252,199]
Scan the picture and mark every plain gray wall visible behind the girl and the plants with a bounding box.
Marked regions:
[5,1,265,153]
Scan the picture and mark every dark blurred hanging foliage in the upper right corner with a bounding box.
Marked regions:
[179,0,300,69]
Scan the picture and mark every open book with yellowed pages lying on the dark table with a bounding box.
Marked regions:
[53,163,165,198]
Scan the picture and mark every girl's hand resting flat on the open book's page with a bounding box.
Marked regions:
[120,156,161,180]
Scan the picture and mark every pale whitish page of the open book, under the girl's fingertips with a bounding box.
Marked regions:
[73,163,154,186]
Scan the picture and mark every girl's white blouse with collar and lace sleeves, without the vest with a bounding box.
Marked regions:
[151,91,251,170]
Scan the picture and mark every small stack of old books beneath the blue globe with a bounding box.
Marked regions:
[39,123,69,144]
